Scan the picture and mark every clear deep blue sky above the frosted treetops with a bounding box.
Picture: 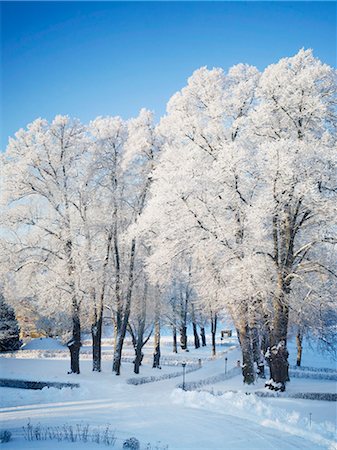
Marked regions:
[0,2,336,150]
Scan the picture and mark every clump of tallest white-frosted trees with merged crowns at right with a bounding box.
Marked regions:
[137,50,336,389]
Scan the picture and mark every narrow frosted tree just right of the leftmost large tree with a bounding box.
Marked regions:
[87,117,127,371]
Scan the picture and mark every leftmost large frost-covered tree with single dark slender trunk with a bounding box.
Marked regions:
[2,116,88,373]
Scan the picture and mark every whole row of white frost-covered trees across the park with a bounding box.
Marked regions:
[1,50,337,389]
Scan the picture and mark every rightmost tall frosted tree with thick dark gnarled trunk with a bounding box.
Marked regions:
[250,50,336,389]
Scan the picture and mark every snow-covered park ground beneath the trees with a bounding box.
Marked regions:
[0,338,337,450]
